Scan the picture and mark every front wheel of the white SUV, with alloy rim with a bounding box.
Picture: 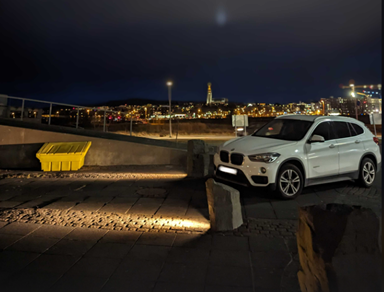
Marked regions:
[276,163,304,200]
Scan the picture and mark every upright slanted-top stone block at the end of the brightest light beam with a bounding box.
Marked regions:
[205,178,243,231]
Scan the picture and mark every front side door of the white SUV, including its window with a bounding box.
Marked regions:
[305,121,339,179]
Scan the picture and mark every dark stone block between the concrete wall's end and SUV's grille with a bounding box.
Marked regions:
[187,140,211,178]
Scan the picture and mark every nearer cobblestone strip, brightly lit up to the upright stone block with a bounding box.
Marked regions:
[0,208,297,238]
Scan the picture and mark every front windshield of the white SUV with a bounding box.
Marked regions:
[252,119,312,141]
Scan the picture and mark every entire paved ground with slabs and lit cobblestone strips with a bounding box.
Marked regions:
[0,168,381,292]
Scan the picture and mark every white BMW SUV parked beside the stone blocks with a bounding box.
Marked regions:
[214,115,381,199]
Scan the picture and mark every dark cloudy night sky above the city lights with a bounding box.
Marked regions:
[0,0,382,105]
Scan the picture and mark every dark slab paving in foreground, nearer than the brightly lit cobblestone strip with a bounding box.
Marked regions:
[0,223,300,292]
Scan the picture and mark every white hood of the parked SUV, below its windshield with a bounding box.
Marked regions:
[220,136,297,155]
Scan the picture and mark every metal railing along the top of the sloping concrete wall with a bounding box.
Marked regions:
[0,94,132,136]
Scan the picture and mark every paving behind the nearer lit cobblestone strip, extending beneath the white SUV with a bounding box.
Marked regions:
[0,170,382,223]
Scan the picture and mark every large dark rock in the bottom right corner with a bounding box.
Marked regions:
[297,204,381,292]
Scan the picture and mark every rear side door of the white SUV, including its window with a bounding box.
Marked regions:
[331,121,365,174]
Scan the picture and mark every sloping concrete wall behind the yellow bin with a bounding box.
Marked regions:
[0,124,187,169]
